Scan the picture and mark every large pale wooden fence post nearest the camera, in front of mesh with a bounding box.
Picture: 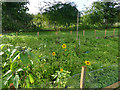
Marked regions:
[80,66,86,90]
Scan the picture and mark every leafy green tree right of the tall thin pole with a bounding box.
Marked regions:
[81,1,118,28]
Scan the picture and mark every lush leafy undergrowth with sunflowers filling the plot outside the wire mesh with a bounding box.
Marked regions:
[1,31,118,88]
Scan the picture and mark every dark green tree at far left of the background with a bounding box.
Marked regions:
[2,2,32,31]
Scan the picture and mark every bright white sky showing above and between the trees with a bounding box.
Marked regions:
[27,0,97,14]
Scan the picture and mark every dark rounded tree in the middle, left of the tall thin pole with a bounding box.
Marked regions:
[43,2,78,29]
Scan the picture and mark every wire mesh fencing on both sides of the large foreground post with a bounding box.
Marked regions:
[66,65,120,89]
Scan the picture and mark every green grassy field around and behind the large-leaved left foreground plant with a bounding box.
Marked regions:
[0,29,119,88]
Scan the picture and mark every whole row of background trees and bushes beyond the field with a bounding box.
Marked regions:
[2,1,120,32]
